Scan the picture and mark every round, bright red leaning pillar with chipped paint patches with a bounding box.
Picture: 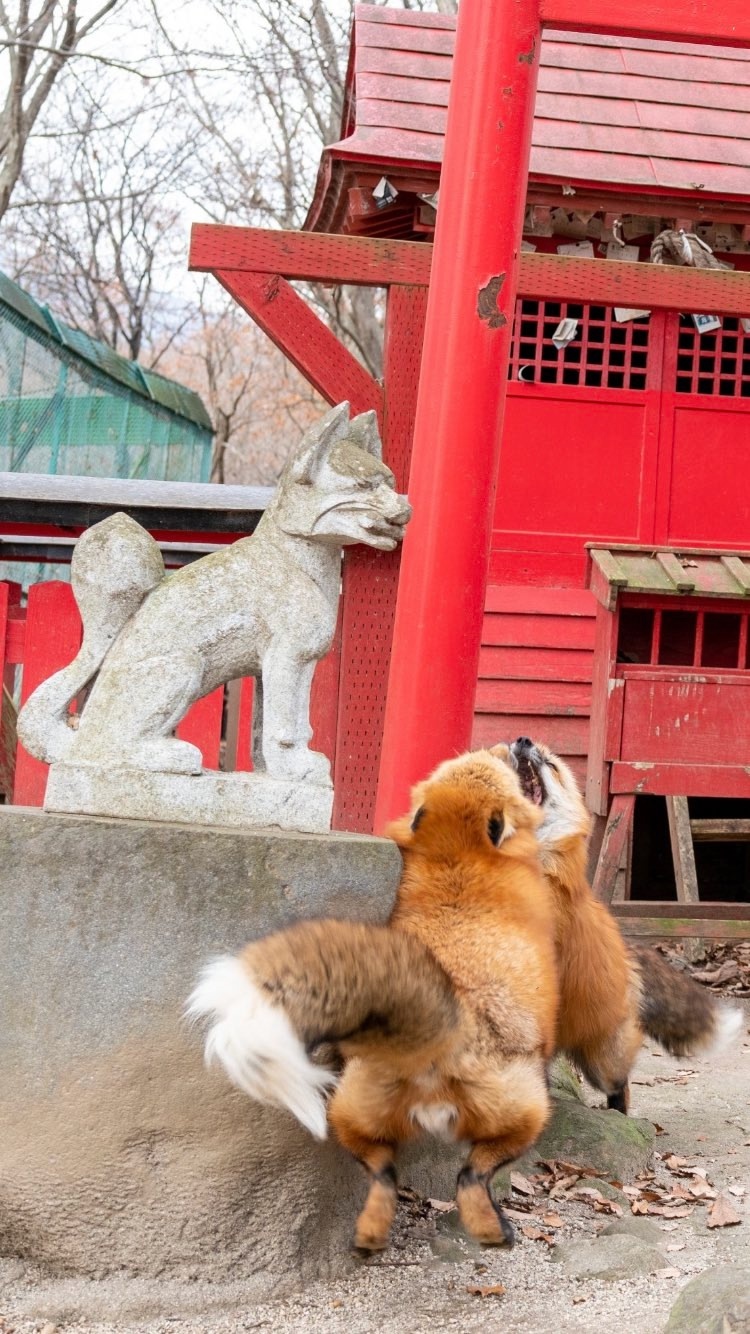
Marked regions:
[375,0,542,832]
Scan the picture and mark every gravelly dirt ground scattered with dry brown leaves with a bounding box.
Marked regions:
[0,998,750,1334]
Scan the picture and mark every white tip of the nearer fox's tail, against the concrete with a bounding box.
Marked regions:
[187,955,336,1139]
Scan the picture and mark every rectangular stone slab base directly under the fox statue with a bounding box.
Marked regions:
[44,763,334,834]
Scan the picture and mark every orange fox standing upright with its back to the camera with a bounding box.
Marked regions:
[188,751,558,1251]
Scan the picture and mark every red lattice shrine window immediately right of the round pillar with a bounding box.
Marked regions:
[508,300,650,390]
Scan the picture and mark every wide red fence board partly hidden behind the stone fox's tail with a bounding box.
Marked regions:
[13,579,81,806]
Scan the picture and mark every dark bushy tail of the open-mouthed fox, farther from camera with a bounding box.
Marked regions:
[631,947,743,1057]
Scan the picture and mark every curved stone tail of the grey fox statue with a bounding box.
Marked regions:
[19,514,164,764]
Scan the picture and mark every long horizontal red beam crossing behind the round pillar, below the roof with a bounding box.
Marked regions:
[190,223,750,316]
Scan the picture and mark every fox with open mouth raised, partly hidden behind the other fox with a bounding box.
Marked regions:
[492,736,743,1113]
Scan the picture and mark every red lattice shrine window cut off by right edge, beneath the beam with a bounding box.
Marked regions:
[675,315,750,399]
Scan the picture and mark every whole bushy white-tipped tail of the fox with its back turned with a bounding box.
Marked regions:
[187,919,459,1139]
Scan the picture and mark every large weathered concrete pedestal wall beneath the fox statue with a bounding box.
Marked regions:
[0,807,454,1295]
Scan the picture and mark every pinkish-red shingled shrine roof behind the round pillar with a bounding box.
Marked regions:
[306,4,750,231]
